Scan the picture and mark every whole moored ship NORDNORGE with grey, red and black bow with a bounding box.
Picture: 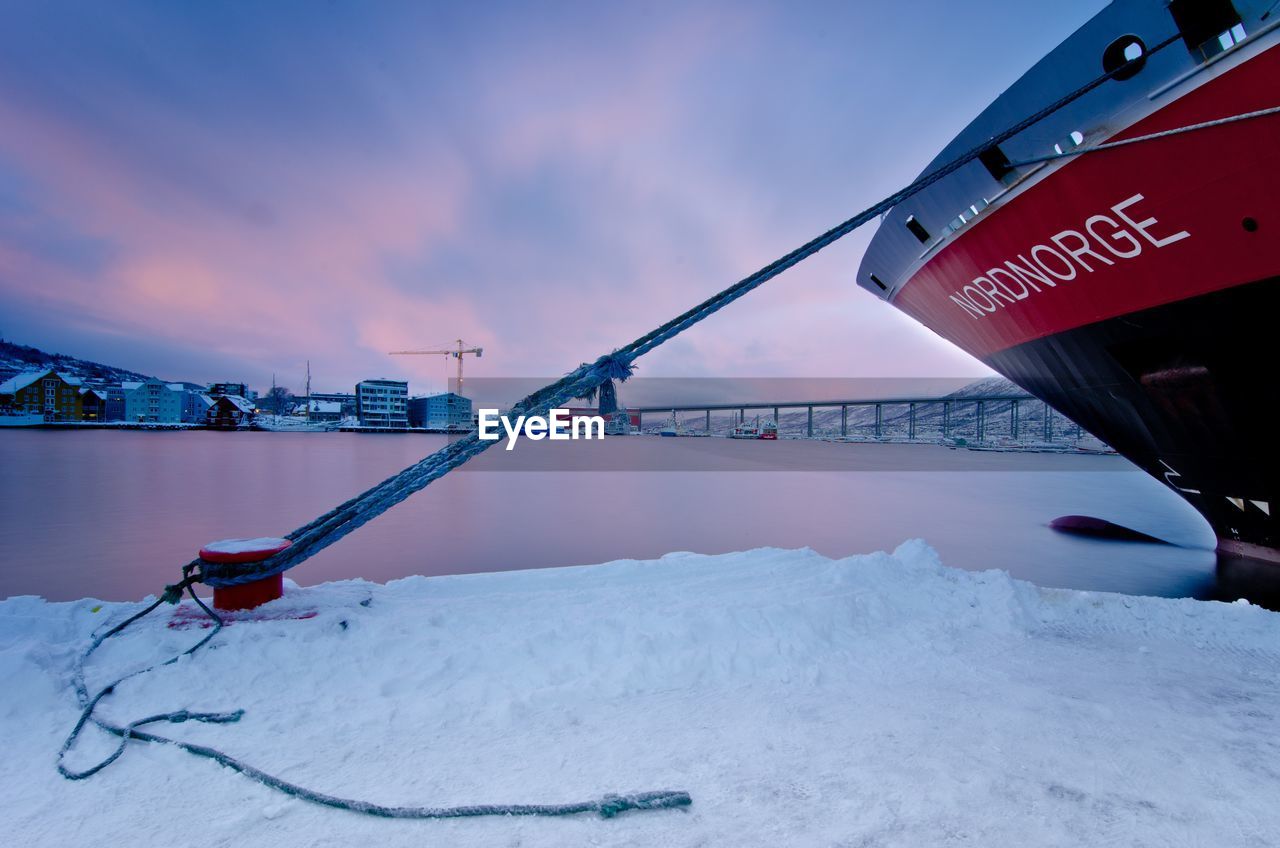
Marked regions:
[858,0,1280,561]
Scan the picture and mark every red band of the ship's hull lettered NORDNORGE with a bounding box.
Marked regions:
[893,42,1280,357]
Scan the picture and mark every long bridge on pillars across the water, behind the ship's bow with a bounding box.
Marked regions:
[627,395,1079,442]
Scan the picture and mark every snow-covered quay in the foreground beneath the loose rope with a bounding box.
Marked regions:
[0,542,1280,847]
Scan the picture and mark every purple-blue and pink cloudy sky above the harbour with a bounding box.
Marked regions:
[0,0,1105,393]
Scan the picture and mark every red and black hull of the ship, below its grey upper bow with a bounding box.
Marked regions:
[893,41,1280,560]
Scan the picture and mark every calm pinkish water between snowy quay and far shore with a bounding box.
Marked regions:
[0,430,1215,599]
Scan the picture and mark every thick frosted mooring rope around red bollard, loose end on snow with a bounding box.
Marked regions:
[58,35,1180,819]
